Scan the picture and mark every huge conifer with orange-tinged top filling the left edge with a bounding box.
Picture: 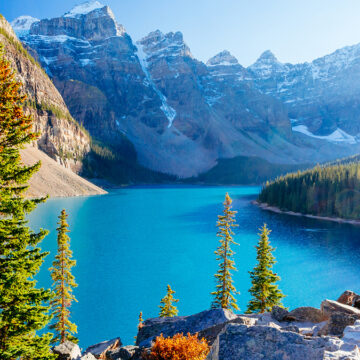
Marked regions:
[0,46,54,360]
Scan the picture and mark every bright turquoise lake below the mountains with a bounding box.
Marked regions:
[30,187,360,348]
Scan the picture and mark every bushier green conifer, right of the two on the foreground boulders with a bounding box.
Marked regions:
[246,224,284,314]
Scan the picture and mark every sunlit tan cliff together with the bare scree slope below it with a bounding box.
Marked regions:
[0,16,105,196]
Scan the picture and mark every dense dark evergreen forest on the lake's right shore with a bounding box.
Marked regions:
[258,161,360,219]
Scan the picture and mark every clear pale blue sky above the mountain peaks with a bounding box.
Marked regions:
[0,0,360,66]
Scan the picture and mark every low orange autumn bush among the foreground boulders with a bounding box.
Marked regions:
[147,333,210,360]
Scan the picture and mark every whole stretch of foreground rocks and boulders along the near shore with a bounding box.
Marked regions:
[54,290,360,360]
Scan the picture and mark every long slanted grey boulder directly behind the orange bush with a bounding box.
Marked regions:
[136,309,238,347]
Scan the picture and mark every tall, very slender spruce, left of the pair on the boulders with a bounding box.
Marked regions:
[211,193,239,310]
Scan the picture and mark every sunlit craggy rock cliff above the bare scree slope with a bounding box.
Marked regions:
[0,13,90,171]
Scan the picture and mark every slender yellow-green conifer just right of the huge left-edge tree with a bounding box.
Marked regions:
[49,210,78,343]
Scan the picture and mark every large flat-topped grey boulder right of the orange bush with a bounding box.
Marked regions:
[207,324,359,360]
